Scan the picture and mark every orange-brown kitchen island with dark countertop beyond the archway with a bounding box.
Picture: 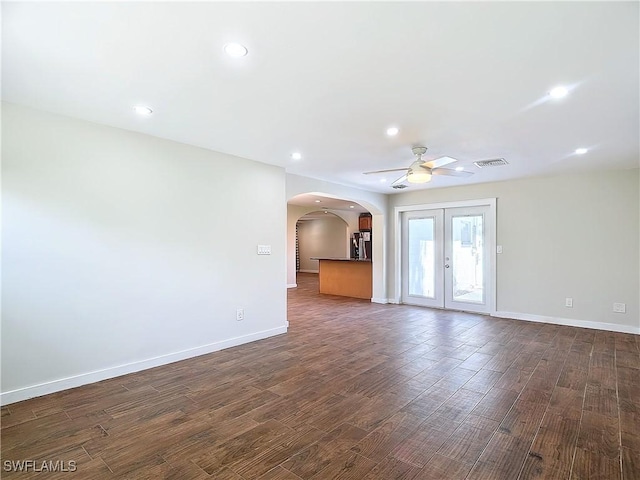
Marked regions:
[314,258,372,300]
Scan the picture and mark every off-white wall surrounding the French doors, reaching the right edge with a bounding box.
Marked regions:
[388,169,640,333]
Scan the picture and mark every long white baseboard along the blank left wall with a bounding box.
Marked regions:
[0,322,289,405]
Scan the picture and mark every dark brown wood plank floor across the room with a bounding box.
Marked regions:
[1,274,640,480]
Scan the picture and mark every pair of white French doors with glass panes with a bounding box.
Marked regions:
[401,205,495,313]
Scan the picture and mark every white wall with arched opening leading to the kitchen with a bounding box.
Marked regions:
[286,174,389,303]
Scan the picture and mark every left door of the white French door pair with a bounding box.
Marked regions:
[402,209,444,308]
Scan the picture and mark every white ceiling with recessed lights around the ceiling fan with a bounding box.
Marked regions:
[2,2,640,193]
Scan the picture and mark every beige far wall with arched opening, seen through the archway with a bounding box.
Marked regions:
[298,214,350,273]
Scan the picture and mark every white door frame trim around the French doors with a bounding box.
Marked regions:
[393,197,497,316]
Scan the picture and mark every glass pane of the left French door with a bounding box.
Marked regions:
[408,217,436,298]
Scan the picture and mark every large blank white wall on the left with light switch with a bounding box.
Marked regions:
[1,104,287,403]
